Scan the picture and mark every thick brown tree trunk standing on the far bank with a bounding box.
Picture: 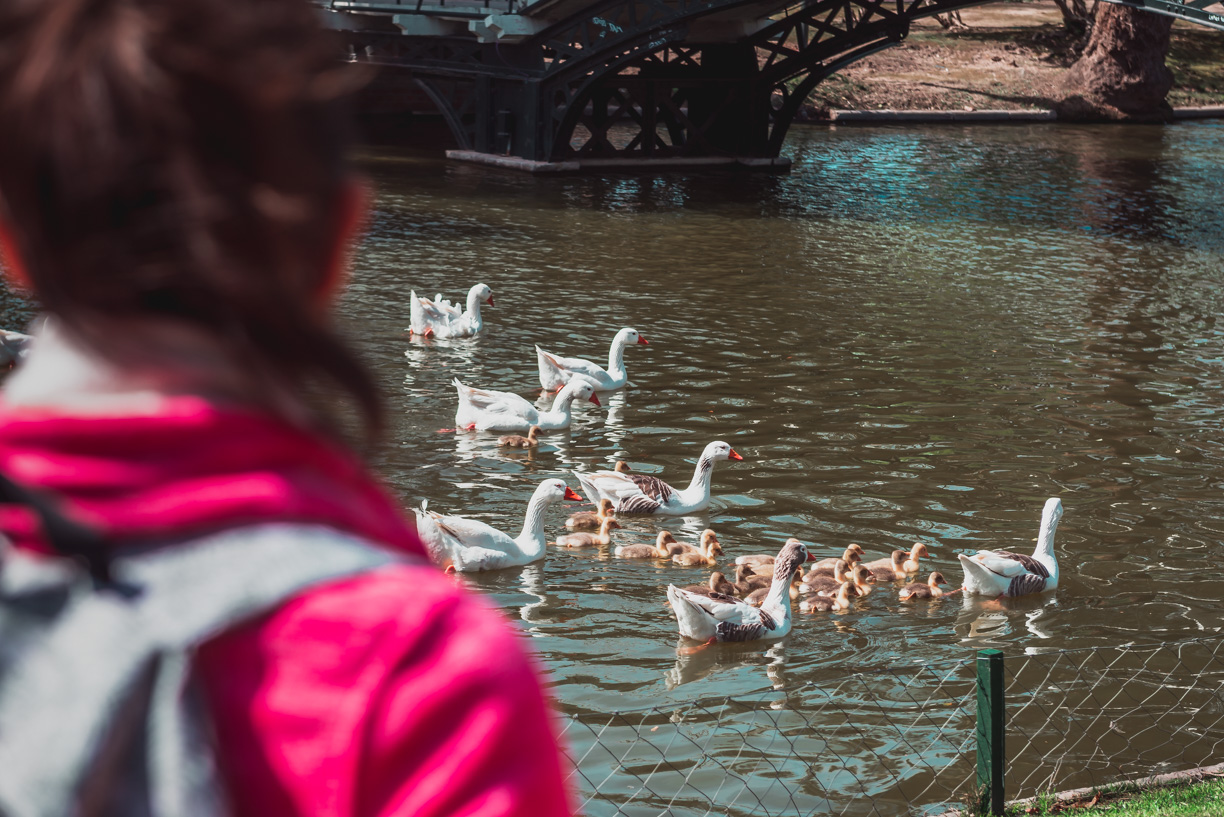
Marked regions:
[1058,2,1173,121]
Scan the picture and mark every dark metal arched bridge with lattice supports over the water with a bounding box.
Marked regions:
[316,0,1224,170]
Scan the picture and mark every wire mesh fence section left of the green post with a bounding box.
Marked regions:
[564,659,976,817]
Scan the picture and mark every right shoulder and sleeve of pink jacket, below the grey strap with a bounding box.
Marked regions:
[197,553,570,817]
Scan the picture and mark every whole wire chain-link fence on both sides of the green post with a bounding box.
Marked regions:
[564,637,1224,817]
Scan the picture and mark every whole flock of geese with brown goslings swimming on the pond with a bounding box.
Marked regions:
[410,284,1062,643]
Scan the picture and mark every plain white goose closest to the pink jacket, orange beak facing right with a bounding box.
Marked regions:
[416,479,583,573]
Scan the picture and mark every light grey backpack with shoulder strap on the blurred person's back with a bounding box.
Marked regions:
[0,524,405,817]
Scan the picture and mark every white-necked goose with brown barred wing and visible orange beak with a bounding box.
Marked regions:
[574,440,743,516]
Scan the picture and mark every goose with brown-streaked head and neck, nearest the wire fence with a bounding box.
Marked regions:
[667,539,808,643]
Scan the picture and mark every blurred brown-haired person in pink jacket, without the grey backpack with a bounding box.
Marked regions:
[0,0,570,817]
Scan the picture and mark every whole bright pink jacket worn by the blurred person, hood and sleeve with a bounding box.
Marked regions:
[0,397,573,817]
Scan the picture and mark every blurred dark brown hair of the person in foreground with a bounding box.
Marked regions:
[0,0,381,429]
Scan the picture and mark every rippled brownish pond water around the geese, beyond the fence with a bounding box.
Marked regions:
[344,124,1224,813]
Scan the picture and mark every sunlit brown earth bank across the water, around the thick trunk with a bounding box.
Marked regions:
[802,0,1224,121]
